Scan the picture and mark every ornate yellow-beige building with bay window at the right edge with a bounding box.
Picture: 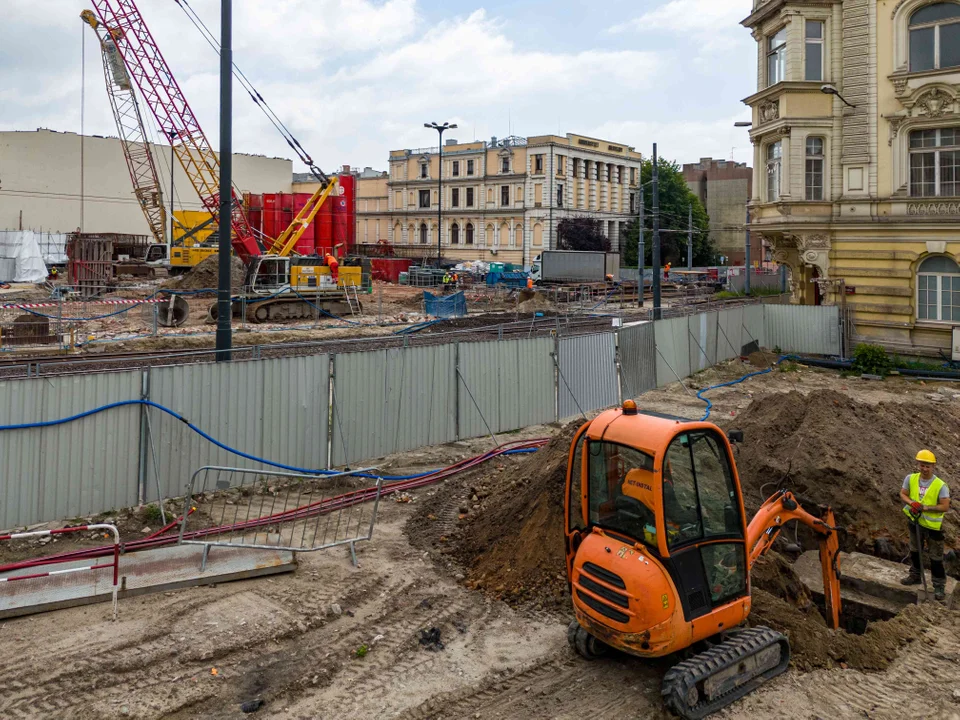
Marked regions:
[743,0,960,354]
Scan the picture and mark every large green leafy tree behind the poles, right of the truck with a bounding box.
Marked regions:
[620,158,717,267]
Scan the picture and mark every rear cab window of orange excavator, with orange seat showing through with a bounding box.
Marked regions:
[587,441,657,548]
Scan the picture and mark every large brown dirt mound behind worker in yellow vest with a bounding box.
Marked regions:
[724,390,960,559]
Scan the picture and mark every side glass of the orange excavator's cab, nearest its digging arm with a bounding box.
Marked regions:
[663,430,743,548]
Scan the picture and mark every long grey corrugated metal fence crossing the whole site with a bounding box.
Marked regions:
[0,305,839,528]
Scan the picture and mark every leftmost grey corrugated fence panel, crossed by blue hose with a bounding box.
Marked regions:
[0,372,140,528]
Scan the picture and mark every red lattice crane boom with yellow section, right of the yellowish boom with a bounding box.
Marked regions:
[93,0,263,264]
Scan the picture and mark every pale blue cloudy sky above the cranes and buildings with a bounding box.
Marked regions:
[0,0,756,172]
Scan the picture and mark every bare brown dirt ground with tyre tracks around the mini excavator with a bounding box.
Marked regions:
[0,362,960,720]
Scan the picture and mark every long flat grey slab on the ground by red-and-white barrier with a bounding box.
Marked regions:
[0,545,297,618]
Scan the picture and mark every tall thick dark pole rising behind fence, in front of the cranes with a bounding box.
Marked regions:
[216,0,233,362]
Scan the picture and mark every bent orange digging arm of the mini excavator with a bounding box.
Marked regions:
[747,490,840,629]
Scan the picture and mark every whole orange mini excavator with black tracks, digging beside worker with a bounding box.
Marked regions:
[564,400,840,718]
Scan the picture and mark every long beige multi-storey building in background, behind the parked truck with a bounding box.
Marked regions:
[357,134,641,266]
